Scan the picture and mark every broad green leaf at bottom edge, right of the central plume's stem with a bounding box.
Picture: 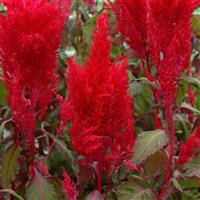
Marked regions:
[117,178,153,200]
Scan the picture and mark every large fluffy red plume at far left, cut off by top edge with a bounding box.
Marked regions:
[0,0,71,177]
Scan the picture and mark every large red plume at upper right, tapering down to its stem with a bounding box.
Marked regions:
[147,0,197,104]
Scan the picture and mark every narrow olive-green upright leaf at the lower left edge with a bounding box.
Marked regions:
[2,146,21,188]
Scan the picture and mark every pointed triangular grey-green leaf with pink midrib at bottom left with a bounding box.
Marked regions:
[25,170,58,200]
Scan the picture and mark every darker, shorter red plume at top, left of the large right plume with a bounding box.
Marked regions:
[113,0,148,58]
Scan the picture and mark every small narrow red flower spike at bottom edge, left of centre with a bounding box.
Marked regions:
[62,171,78,200]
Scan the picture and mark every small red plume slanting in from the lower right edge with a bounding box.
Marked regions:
[178,126,200,164]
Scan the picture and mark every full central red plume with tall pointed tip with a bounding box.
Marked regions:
[62,14,134,190]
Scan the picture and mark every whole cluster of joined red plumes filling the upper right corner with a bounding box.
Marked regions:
[113,0,199,107]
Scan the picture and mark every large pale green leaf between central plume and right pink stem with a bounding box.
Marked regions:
[134,129,168,164]
